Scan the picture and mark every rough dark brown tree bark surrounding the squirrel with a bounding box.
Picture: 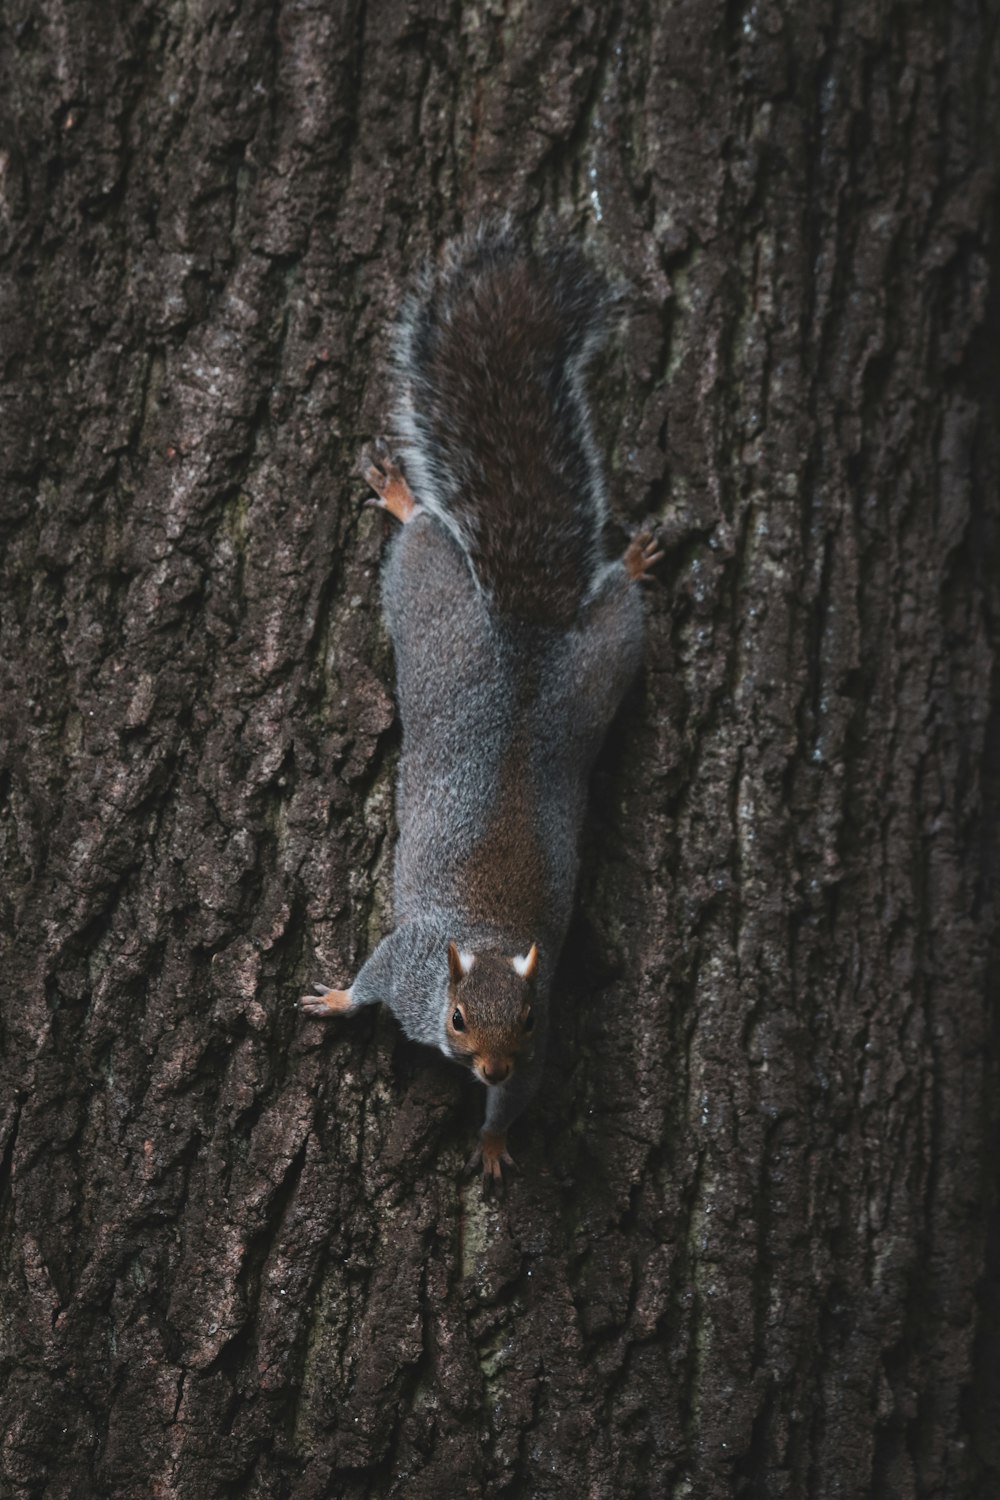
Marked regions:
[0,0,1000,1500]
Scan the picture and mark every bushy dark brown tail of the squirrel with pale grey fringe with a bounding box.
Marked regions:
[396,222,616,626]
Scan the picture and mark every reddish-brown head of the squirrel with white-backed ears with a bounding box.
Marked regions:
[445,942,538,1083]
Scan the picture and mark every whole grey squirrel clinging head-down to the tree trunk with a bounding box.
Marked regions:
[300,221,663,1190]
